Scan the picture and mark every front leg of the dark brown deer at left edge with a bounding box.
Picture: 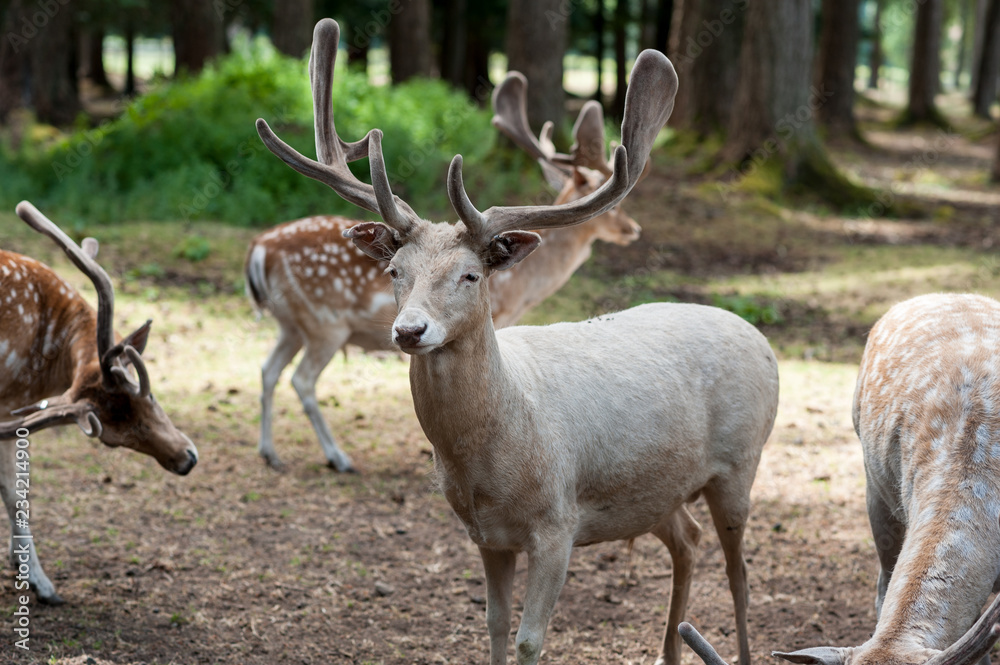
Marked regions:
[0,440,63,605]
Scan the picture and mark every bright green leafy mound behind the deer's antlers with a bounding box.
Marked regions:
[0,42,495,226]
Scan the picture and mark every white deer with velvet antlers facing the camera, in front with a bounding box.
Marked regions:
[257,19,778,665]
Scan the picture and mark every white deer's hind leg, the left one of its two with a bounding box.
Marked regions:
[652,505,701,665]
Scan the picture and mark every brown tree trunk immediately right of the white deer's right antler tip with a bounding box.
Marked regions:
[672,0,746,136]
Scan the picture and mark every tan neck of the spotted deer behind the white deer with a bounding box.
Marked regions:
[490,224,595,328]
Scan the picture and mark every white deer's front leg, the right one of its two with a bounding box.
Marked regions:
[514,537,573,665]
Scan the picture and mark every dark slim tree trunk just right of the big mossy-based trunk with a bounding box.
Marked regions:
[816,0,861,135]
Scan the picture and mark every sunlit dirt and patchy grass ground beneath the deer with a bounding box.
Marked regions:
[0,94,1000,665]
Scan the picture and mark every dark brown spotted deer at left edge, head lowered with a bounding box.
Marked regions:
[0,202,198,604]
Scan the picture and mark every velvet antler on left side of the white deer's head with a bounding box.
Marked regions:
[257,18,418,235]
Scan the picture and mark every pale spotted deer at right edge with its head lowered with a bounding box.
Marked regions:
[685,294,1000,665]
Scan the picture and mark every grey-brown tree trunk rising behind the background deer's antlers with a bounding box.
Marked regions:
[507,0,570,136]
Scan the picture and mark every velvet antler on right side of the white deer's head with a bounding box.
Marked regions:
[448,49,677,242]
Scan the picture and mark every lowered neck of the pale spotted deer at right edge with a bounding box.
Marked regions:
[872,476,1000,649]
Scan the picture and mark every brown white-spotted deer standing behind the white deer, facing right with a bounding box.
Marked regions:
[244,68,640,471]
